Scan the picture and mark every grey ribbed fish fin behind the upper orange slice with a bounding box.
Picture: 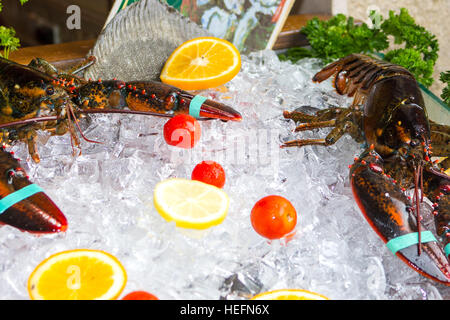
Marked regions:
[84,0,211,82]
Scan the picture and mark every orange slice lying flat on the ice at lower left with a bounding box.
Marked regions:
[28,249,127,300]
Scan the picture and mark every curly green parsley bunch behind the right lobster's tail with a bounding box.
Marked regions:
[280,8,439,87]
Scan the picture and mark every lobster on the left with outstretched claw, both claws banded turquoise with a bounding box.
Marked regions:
[0,57,241,234]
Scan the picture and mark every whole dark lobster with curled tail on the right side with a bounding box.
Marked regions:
[282,54,450,286]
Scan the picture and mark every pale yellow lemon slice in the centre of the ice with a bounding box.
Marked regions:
[153,178,230,229]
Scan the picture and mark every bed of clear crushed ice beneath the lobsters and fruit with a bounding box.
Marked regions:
[0,51,450,299]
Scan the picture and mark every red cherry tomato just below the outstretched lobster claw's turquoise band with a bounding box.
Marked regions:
[163,114,201,149]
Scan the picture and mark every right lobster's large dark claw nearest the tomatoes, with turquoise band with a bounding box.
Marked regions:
[350,150,450,285]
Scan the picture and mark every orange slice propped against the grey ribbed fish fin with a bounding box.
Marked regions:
[160,37,241,90]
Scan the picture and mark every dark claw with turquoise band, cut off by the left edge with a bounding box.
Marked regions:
[0,150,67,234]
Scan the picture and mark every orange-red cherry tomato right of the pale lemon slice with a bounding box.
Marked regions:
[250,195,297,240]
